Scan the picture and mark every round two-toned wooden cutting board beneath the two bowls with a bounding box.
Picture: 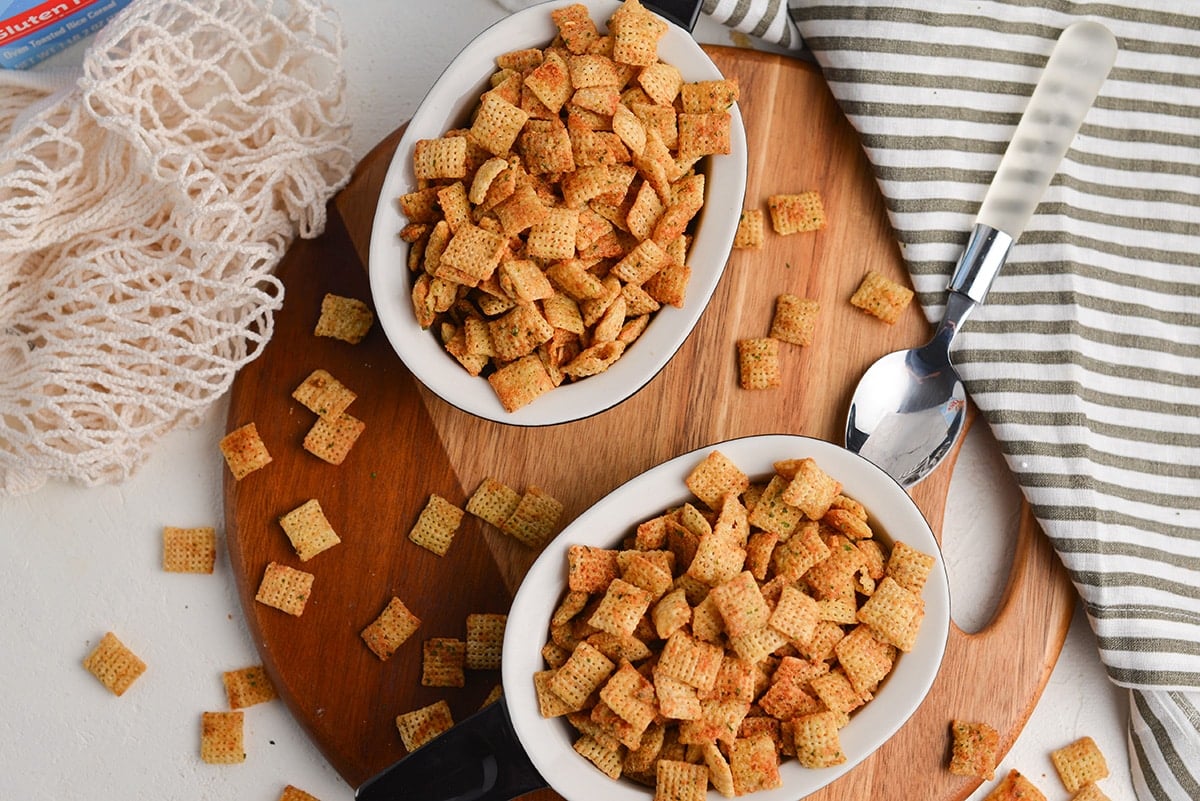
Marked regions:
[224,47,1074,801]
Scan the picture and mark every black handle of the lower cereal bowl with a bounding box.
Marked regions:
[354,699,546,801]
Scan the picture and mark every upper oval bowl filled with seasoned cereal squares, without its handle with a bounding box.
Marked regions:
[368,0,746,426]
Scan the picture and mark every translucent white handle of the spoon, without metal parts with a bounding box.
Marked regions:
[977,22,1117,240]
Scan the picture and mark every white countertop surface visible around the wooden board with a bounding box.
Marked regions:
[0,0,1134,801]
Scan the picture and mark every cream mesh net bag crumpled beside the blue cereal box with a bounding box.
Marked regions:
[0,0,353,494]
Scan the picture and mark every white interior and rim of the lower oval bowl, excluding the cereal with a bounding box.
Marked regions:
[502,434,950,801]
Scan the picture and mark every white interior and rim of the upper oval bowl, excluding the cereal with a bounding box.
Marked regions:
[368,0,746,426]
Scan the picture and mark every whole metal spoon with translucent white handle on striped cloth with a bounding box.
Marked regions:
[846,22,1117,487]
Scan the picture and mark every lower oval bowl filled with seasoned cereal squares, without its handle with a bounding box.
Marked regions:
[502,435,950,801]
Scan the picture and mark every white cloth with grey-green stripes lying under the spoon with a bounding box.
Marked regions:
[492,0,1200,801]
